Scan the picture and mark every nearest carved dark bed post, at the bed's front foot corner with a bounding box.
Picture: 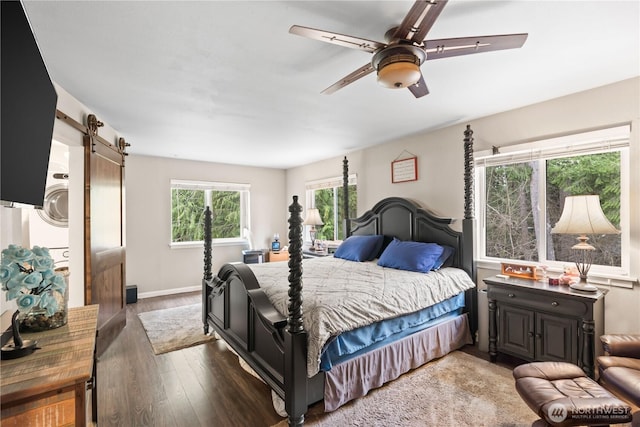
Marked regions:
[284,196,307,426]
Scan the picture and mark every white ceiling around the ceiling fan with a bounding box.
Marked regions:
[23,0,640,168]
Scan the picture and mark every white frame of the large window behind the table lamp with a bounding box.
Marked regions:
[474,125,631,284]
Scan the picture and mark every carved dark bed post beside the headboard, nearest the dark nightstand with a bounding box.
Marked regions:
[462,125,478,340]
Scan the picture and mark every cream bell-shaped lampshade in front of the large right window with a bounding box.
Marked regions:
[551,195,620,234]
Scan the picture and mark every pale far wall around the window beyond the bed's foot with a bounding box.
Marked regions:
[125,155,287,298]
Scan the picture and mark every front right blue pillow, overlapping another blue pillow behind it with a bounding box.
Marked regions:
[378,239,444,273]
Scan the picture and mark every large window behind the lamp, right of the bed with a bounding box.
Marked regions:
[476,126,629,274]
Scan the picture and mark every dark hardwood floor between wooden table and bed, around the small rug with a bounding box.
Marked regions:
[97,292,520,427]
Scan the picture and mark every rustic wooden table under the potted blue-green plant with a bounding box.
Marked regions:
[0,305,98,427]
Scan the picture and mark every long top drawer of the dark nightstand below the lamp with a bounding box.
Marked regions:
[488,285,589,317]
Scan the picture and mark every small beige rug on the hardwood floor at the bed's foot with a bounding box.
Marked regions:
[138,304,213,354]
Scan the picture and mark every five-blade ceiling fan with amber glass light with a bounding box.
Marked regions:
[289,0,528,98]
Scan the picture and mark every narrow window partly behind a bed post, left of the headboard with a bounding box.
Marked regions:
[306,175,358,240]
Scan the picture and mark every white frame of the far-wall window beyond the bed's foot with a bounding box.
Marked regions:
[169,179,251,248]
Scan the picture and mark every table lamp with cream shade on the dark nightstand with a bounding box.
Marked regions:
[551,195,620,283]
